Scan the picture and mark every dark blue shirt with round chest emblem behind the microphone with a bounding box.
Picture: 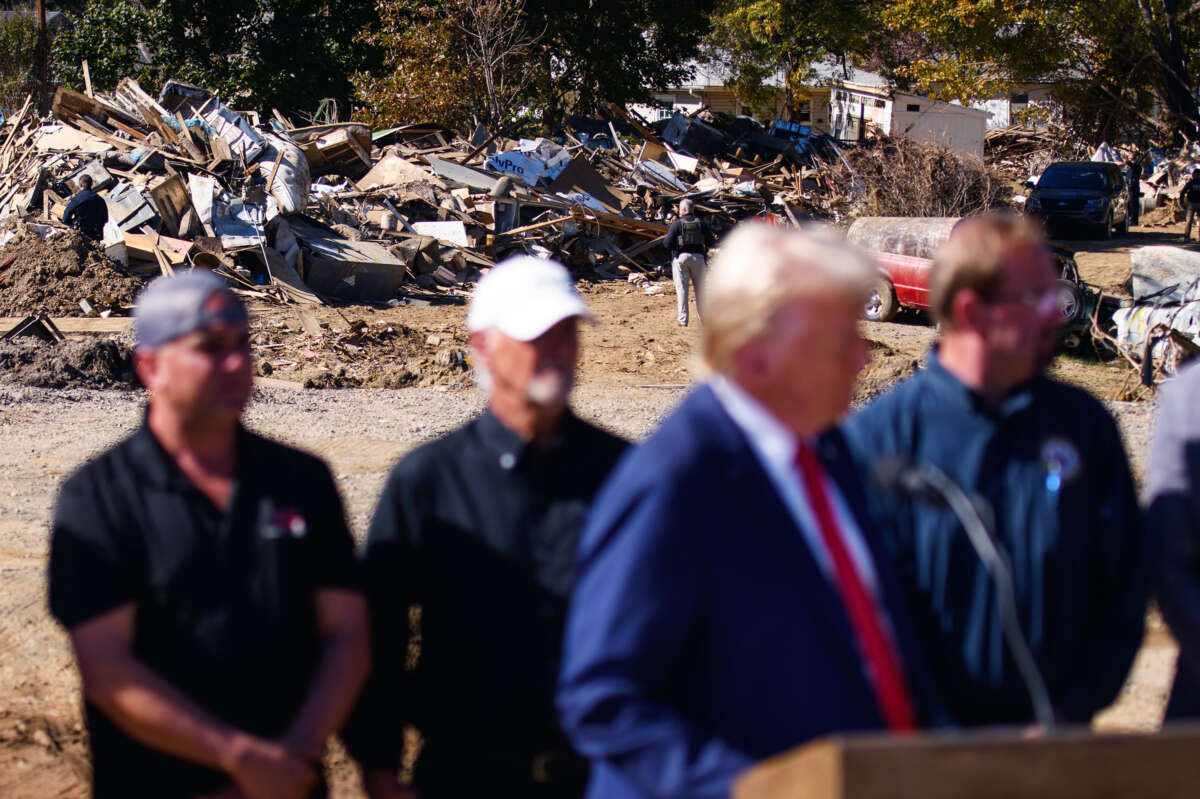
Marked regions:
[845,350,1146,723]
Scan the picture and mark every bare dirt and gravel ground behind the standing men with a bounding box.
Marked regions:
[0,219,1181,799]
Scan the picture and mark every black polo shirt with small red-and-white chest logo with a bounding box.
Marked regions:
[49,423,358,799]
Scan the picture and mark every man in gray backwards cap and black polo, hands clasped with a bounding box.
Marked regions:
[49,270,370,799]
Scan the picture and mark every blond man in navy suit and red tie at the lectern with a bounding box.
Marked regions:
[558,222,943,799]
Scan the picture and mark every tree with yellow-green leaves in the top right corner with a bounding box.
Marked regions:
[881,0,1200,140]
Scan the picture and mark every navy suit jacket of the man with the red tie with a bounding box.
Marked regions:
[558,386,943,799]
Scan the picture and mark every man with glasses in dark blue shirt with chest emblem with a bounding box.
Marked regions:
[846,216,1146,725]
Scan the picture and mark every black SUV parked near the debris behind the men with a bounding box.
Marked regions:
[1025,161,1129,239]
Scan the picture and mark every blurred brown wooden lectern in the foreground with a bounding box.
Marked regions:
[733,725,1200,799]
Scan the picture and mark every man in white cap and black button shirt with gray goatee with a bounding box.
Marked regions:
[347,257,625,799]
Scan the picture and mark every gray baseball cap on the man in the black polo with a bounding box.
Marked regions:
[133,269,250,349]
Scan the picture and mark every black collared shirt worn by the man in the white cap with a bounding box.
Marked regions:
[347,411,626,795]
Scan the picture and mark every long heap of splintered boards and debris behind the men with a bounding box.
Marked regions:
[0,79,840,316]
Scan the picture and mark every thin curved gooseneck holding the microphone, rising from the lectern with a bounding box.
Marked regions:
[916,463,1055,732]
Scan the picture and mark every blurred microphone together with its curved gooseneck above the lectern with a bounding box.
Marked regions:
[874,456,1055,732]
